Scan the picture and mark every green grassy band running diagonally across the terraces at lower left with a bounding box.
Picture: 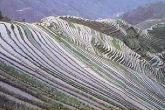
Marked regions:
[0,63,89,108]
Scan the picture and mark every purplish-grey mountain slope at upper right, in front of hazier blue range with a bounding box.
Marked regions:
[121,1,165,25]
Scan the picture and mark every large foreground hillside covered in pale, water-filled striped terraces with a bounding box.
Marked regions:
[0,16,165,110]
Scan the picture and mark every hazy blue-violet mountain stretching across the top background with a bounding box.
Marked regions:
[0,0,164,22]
